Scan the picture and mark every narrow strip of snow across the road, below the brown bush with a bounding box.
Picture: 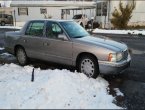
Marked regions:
[93,28,145,35]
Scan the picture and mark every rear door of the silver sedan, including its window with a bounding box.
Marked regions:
[20,21,45,59]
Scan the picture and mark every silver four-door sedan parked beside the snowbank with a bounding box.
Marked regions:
[5,20,131,78]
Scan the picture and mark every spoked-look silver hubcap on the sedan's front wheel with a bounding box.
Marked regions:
[81,59,95,77]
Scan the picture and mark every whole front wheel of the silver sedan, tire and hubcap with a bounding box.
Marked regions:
[78,55,99,78]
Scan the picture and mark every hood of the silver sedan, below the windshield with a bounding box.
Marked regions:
[73,36,127,51]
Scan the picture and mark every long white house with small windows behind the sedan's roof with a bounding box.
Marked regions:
[10,0,96,25]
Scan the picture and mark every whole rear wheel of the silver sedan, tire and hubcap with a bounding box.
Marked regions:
[16,47,28,66]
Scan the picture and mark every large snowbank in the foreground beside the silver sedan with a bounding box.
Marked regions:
[0,64,120,109]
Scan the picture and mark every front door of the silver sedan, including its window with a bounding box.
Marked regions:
[44,21,72,65]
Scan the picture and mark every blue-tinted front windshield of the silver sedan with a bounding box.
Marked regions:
[60,21,89,38]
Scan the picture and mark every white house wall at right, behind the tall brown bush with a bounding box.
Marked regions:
[95,0,145,28]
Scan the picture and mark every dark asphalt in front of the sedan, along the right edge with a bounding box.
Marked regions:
[95,34,145,109]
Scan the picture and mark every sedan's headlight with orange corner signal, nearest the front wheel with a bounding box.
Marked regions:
[108,53,123,62]
